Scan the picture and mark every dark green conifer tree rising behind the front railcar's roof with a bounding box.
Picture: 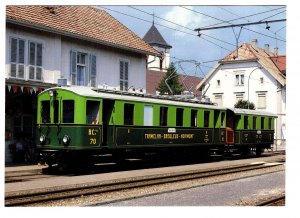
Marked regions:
[156,62,183,95]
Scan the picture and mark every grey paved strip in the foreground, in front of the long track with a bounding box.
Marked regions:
[103,171,285,206]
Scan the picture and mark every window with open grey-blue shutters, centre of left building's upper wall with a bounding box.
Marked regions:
[71,51,96,87]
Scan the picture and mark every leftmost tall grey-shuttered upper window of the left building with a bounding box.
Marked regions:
[10,38,25,79]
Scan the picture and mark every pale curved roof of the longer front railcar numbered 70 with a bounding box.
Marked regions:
[41,86,227,110]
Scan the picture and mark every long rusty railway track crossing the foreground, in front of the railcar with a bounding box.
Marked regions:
[5,160,284,206]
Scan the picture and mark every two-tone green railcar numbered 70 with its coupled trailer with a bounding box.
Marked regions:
[36,87,275,166]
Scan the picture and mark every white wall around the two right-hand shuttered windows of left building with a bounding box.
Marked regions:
[61,40,146,90]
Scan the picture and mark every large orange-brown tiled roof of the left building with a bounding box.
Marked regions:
[6,6,159,55]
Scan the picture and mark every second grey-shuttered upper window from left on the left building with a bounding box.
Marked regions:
[28,42,43,80]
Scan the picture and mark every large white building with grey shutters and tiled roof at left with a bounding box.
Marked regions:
[5,6,160,162]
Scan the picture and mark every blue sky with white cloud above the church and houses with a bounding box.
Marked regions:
[98,5,286,77]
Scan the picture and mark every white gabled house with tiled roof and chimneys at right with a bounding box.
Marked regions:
[198,40,286,148]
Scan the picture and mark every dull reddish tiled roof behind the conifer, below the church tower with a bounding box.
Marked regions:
[146,70,202,96]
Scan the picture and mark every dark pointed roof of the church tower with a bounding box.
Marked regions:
[143,22,172,49]
